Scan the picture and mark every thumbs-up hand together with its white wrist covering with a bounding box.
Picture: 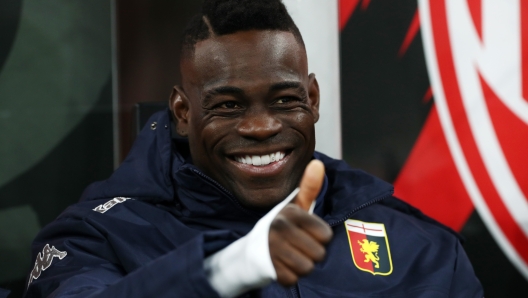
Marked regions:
[204,160,332,297]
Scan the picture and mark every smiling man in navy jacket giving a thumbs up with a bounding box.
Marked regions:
[26,0,482,297]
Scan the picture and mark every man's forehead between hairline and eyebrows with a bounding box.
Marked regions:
[182,30,308,89]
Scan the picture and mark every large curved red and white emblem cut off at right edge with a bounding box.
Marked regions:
[419,0,528,278]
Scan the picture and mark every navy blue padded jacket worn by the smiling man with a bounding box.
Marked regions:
[26,111,483,297]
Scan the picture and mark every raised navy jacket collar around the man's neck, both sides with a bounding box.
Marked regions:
[81,109,392,228]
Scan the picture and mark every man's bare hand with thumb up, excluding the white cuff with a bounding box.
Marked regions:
[269,160,332,286]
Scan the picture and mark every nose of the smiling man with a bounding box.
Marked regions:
[236,111,282,141]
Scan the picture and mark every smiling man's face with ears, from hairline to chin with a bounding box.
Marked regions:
[175,30,319,209]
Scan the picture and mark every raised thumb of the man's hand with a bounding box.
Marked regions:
[294,159,324,211]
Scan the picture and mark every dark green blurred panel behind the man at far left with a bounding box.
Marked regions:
[0,0,113,297]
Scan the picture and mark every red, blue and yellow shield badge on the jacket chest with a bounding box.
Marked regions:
[345,219,392,275]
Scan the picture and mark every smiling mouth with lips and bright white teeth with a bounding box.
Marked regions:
[229,150,291,176]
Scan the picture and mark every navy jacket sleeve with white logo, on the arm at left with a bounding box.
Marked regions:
[25,211,226,297]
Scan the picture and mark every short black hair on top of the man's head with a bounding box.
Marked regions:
[182,0,304,52]
